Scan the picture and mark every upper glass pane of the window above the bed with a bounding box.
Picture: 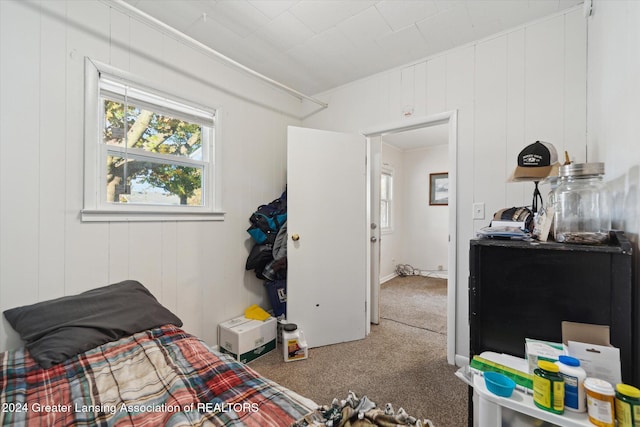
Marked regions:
[103,98,202,160]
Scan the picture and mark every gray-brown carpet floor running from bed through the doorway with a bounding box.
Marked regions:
[249,276,467,427]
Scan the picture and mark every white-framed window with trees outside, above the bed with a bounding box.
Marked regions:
[82,58,224,221]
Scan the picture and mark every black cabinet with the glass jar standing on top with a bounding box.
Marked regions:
[469,232,640,387]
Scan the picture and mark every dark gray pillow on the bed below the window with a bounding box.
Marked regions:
[4,280,182,368]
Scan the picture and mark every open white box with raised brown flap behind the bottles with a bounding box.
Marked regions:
[562,321,622,387]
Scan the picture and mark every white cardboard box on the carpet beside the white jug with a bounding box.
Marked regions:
[218,316,277,363]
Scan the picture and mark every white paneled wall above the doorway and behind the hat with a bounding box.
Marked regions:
[305,8,587,362]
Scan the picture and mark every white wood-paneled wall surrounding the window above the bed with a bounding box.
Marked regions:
[0,1,300,350]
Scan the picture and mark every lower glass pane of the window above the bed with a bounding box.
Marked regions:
[106,155,203,206]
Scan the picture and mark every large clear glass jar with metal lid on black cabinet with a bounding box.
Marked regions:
[553,163,611,244]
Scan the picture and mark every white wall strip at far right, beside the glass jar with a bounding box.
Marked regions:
[587,0,640,300]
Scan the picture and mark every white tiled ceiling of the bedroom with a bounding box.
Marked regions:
[125,0,582,95]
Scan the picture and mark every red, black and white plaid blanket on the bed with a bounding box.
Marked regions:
[0,325,315,427]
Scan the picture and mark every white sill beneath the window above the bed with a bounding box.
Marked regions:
[80,209,225,222]
